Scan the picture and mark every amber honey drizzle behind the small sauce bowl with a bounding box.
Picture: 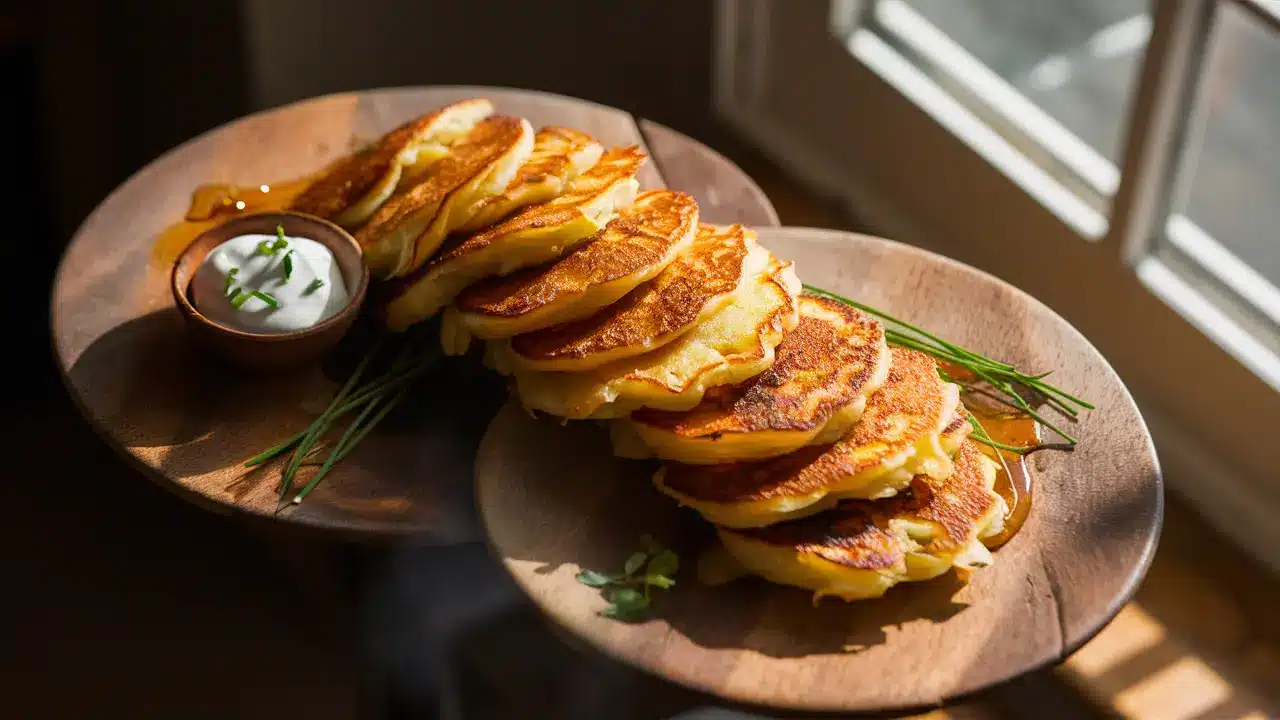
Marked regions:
[151,176,312,269]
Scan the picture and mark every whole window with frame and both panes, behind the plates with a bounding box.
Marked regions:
[717,0,1280,566]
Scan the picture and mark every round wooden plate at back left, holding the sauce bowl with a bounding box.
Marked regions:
[51,87,776,542]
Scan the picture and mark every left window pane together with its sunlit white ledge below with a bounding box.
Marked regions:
[841,0,1151,226]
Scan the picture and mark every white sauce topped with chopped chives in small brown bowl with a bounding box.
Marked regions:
[191,234,349,333]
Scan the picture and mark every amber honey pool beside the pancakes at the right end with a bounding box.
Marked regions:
[940,363,1041,550]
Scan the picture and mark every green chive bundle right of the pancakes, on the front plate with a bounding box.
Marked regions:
[804,284,1093,454]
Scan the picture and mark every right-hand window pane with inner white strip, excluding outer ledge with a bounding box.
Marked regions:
[1164,3,1280,322]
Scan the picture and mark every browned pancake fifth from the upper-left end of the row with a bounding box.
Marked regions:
[440,190,698,355]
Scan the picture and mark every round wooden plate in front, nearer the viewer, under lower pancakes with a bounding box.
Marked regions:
[476,228,1164,712]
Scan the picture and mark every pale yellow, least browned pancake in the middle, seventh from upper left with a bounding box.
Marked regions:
[499,246,800,419]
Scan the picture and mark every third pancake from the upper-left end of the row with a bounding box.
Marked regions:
[457,127,604,232]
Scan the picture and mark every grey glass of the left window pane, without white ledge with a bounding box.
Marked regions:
[908,0,1151,165]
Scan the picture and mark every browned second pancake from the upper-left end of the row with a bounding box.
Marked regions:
[356,115,532,278]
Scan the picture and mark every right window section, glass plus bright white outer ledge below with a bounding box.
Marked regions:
[1151,4,1280,384]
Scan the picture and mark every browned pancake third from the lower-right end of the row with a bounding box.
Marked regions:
[614,296,890,464]
